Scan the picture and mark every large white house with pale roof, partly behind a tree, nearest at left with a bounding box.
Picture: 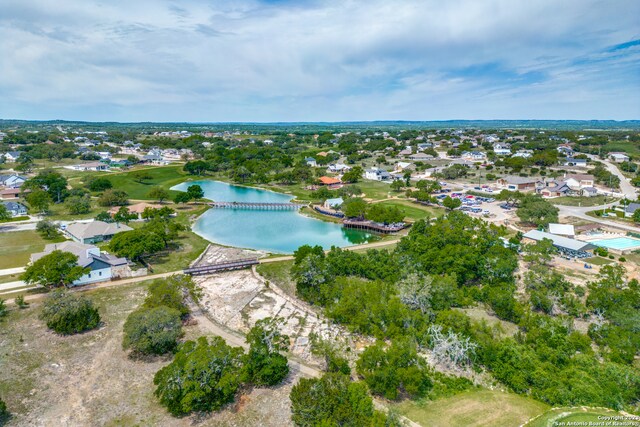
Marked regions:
[31,241,131,286]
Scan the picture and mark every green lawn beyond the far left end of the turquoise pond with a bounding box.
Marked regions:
[107,165,189,200]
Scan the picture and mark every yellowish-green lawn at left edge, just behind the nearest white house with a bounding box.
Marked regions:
[0,230,64,270]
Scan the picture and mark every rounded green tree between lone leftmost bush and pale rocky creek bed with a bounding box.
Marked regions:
[122,305,182,355]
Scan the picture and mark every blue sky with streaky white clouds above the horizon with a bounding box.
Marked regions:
[0,0,640,122]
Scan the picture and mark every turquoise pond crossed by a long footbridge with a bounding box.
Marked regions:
[172,180,379,253]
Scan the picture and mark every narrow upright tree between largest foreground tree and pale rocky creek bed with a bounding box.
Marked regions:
[245,317,289,386]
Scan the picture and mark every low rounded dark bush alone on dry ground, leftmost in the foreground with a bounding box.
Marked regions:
[40,289,100,335]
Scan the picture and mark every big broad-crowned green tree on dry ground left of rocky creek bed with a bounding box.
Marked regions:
[153,337,243,416]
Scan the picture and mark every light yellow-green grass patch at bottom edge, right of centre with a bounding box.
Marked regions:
[395,389,549,427]
